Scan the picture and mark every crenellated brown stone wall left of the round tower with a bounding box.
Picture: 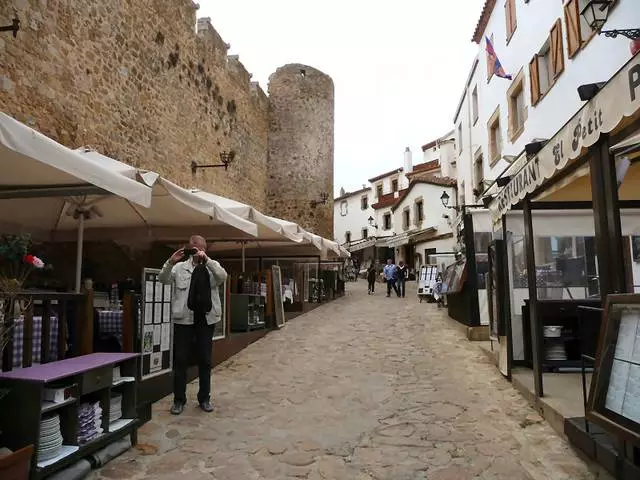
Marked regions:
[0,0,268,209]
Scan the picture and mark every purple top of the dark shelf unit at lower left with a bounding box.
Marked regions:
[0,353,138,383]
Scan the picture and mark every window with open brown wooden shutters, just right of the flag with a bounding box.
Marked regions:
[529,20,564,105]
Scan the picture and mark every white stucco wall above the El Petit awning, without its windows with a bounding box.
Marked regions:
[454,0,640,203]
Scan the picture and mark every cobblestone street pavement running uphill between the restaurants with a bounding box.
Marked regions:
[91,281,597,480]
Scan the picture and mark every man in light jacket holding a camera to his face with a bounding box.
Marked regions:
[158,235,227,415]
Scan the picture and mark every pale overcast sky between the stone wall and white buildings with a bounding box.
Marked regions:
[198,0,484,195]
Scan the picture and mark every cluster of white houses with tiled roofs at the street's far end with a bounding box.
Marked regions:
[334,146,457,269]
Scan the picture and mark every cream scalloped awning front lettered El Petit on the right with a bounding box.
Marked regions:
[489,54,640,225]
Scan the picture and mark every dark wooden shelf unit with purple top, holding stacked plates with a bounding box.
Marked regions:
[0,353,140,480]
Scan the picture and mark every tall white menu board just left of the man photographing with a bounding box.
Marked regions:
[140,268,173,379]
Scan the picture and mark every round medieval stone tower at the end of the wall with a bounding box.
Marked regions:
[267,64,334,238]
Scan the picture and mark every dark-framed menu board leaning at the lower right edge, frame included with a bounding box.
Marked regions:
[586,294,640,446]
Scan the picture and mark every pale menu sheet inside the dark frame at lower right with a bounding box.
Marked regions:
[605,306,640,424]
